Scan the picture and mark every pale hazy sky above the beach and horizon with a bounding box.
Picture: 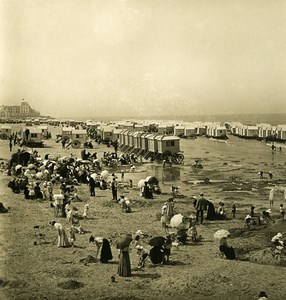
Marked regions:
[0,0,286,117]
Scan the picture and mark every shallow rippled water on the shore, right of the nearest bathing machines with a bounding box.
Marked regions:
[145,135,286,188]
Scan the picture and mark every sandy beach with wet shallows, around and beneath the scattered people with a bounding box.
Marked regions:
[0,127,286,300]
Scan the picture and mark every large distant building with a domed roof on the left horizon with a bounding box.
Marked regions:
[0,101,41,118]
